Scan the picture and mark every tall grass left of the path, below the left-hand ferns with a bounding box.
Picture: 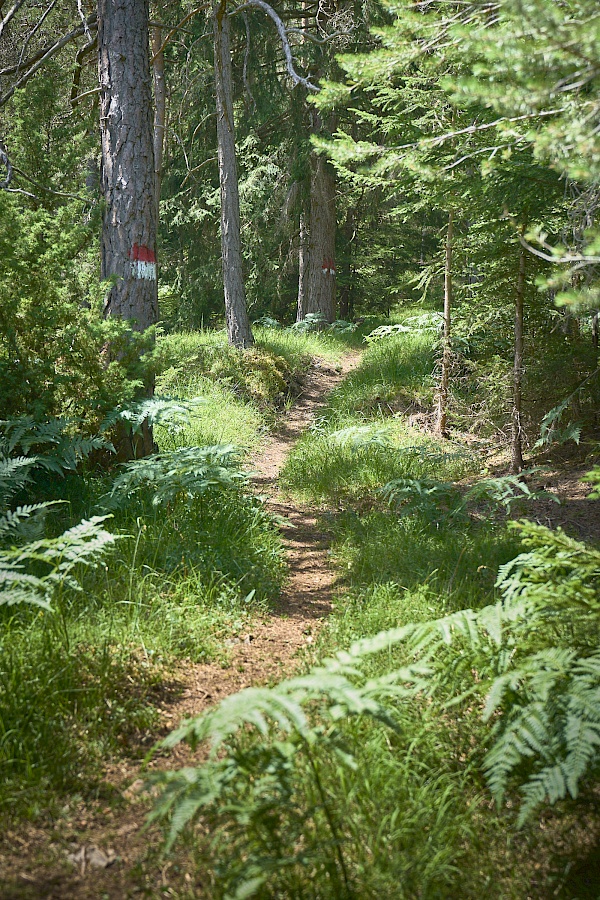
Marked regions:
[0,464,284,814]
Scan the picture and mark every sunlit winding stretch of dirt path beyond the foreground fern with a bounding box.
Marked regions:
[157,353,360,728]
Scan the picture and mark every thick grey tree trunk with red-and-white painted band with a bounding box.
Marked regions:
[98,0,158,331]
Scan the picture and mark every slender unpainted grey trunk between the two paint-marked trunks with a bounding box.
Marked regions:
[212,0,253,347]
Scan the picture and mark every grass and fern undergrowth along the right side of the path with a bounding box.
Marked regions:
[157,312,600,900]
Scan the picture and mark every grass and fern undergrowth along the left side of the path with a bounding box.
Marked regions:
[0,336,300,817]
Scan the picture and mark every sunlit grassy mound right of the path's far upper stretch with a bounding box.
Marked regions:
[282,331,479,501]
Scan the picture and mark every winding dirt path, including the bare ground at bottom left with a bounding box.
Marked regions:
[0,353,359,900]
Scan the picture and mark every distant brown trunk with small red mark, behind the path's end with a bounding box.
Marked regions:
[304,155,336,322]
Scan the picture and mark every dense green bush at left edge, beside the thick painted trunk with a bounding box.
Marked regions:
[0,191,154,430]
